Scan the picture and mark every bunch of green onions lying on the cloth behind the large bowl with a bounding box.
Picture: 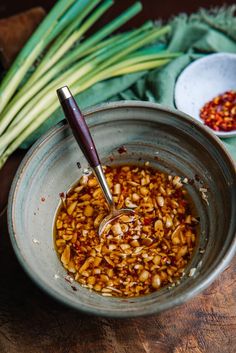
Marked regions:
[0,0,181,168]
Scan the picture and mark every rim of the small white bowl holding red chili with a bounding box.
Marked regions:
[174,52,236,138]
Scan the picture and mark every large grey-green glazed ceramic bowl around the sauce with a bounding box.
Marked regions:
[8,102,236,317]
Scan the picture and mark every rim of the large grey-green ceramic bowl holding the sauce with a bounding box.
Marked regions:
[7,100,236,318]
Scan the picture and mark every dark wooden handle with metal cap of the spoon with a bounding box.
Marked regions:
[57,86,100,168]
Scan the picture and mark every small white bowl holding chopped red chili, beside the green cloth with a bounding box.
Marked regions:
[175,53,236,138]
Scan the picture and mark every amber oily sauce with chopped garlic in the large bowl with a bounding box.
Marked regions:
[55,163,198,297]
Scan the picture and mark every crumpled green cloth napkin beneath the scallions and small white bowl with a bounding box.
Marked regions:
[21,5,236,160]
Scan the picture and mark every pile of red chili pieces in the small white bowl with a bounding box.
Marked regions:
[200,91,236,131]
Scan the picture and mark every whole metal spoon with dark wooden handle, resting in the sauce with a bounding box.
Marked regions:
[57,86,134,236]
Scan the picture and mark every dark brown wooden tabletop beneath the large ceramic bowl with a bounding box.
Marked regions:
[0,0,236,353]
